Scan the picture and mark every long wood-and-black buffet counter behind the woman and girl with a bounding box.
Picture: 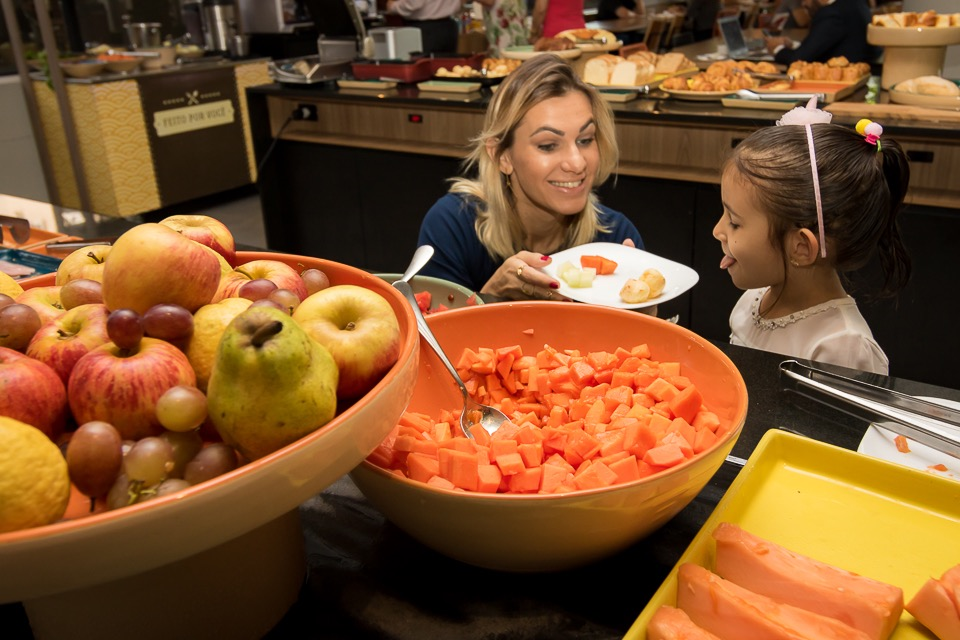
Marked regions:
[247,82,960,385]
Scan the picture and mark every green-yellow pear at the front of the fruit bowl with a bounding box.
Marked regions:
[207,306,339,460]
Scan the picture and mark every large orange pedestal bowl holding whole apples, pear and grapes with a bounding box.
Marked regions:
[0,252,419,638]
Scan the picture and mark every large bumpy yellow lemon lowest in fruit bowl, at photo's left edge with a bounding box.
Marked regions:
[0,416,70,533]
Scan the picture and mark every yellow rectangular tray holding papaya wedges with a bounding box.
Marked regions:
[624,430,960,640]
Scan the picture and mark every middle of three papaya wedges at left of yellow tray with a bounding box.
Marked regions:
[677,562,869,640]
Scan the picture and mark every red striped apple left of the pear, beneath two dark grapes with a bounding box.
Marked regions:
[67,338,197,440]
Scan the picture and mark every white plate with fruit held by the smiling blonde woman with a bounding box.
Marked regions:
[543,242,700,309]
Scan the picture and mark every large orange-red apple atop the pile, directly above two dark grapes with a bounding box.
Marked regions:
[103,222,220,314]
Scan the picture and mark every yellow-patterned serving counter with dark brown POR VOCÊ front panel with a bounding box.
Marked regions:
[31,59,270,216]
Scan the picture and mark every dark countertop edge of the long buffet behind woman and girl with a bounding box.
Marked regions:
[247,80,960,140]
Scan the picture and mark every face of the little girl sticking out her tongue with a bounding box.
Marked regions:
[713,167,785,290]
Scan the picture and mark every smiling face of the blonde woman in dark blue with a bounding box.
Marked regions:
[500,91,600,216]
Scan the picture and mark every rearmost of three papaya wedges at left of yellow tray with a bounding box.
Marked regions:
[713,522,903,640]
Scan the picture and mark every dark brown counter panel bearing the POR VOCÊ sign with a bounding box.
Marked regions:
[137,65,251,207]
